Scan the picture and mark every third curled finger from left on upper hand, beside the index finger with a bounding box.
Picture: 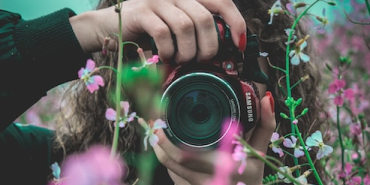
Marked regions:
[176,1,218,61]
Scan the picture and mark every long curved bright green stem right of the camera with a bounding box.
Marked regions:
[285,0,322,179]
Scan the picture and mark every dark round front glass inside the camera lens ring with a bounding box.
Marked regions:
[171,84,225,139]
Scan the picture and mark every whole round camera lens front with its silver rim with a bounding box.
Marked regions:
[162,72,240,150]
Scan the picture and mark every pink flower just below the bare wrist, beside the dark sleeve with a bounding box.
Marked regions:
[78,59,104,93]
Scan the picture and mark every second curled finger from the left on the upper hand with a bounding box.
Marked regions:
[153,1,196,63]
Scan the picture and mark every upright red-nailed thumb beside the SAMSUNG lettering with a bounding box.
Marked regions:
[249,91,276,153]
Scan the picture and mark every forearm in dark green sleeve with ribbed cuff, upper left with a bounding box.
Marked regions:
[0,9,91,132]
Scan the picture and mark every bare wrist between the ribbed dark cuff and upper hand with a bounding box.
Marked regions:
[69,11,104,53]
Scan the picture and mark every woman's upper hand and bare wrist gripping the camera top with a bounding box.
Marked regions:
[71,0,246,63]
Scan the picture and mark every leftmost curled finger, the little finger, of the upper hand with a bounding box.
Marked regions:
[137,11,175,60]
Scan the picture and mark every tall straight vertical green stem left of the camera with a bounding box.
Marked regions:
[111,0,123,157]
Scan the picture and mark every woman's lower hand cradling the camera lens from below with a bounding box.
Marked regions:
[154,94,276,185]
